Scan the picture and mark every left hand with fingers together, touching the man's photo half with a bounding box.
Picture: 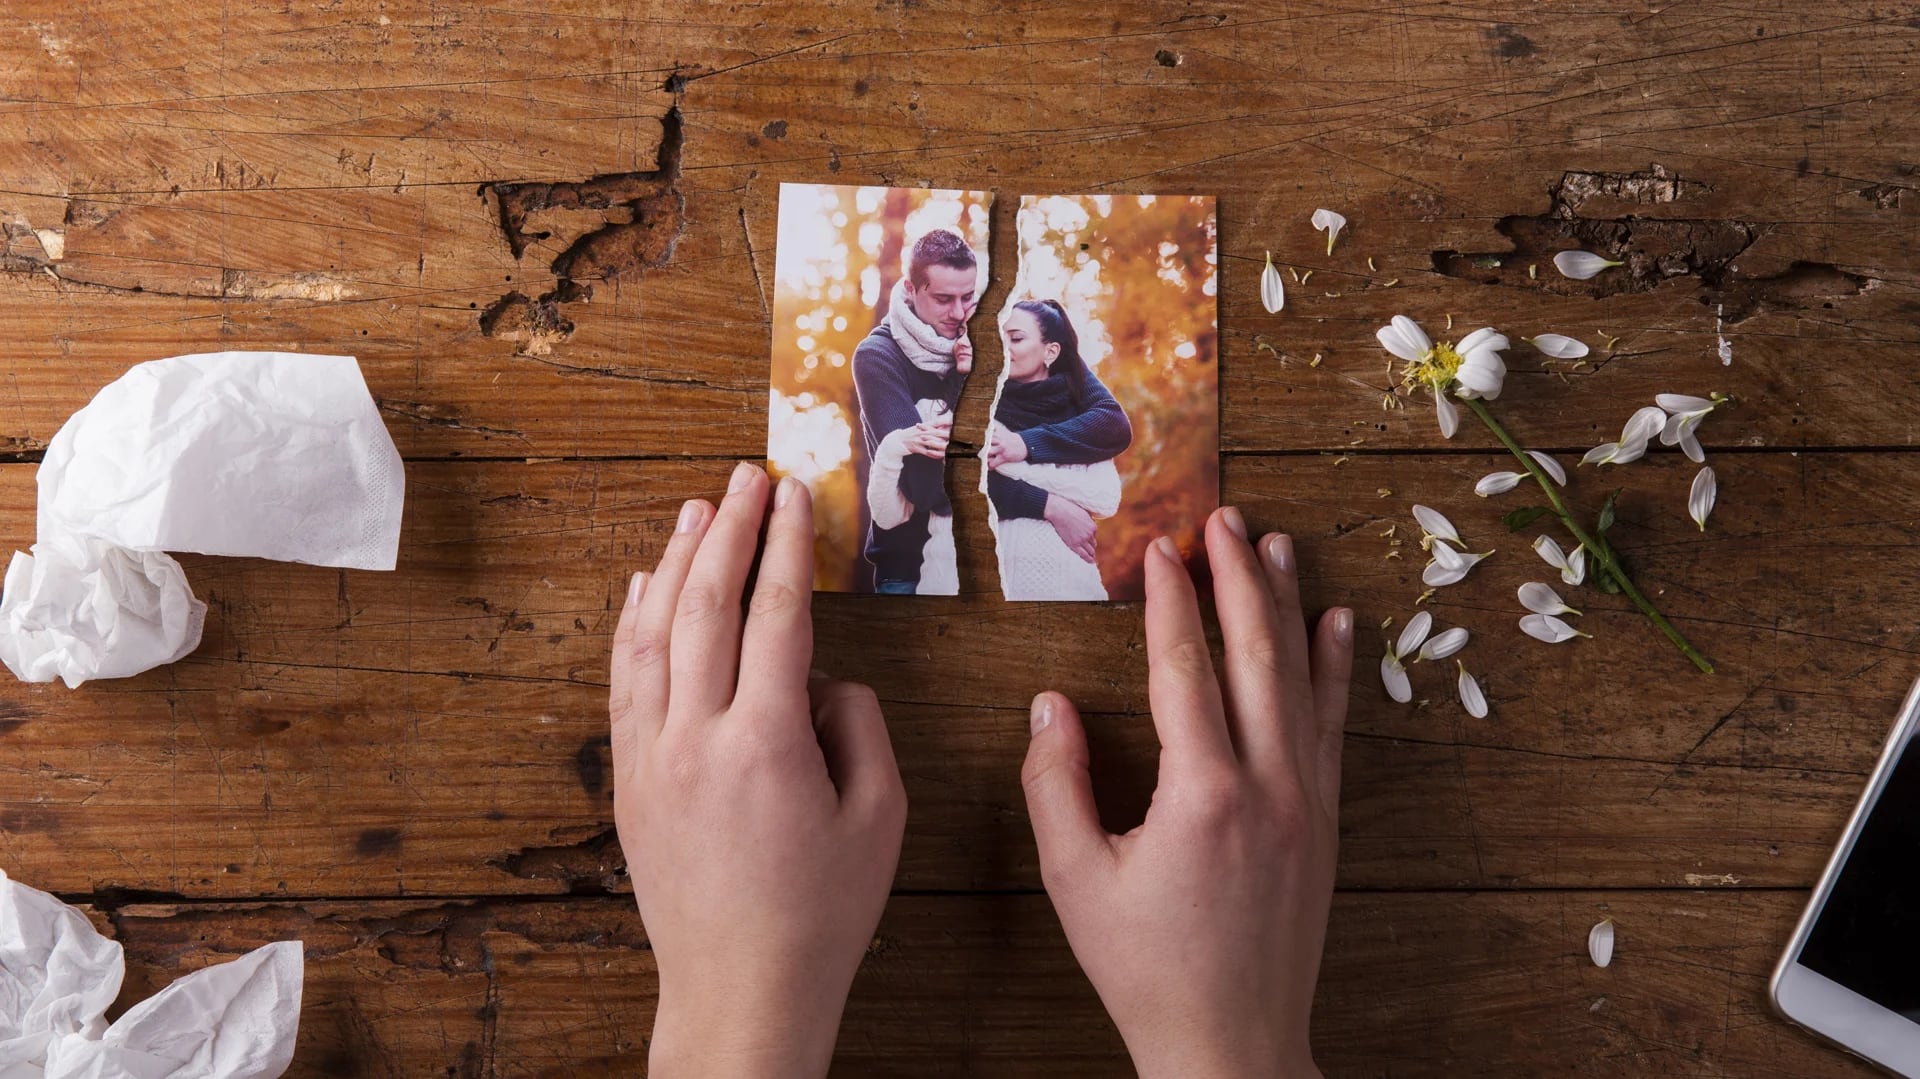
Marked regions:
[609,465,906,1077]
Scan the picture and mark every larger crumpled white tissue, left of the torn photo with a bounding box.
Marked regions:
[0,351,405,687]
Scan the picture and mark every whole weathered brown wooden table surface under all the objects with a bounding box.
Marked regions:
[0,0,1920,1077]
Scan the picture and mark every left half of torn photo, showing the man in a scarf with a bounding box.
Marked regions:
[766,184,993,595]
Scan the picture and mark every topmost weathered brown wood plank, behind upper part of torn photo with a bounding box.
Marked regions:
[0,4,1920,457]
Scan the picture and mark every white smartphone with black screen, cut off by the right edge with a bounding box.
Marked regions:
[1766,668,1920,1077]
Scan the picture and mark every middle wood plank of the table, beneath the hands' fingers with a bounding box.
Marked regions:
[0,453,1896,897]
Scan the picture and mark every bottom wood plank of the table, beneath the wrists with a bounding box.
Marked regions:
[93,891,1870,1077]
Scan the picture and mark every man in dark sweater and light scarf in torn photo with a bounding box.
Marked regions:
[852,228,979,595]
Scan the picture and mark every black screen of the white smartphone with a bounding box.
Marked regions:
[1799,721,1920,1023]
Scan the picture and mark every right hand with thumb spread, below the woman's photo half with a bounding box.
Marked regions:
[1021,507,1354,1079]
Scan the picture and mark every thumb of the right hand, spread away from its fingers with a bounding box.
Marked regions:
[1020,691,1112,891]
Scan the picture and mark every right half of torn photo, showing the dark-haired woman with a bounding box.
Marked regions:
[981,196,1219,599]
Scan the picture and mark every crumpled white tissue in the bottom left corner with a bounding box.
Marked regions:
[0,872,305,1079]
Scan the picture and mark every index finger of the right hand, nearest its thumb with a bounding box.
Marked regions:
[1146,536,1235,764]
